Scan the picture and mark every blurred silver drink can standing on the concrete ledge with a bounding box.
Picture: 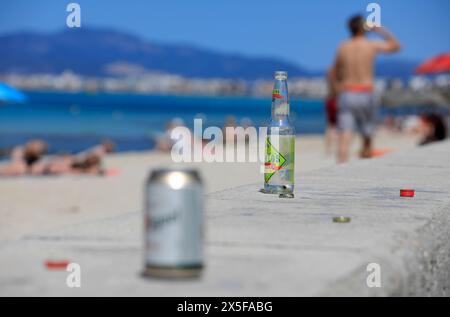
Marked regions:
[144,169,204,278]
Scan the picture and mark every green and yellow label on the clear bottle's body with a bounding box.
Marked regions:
[264,135,295,184]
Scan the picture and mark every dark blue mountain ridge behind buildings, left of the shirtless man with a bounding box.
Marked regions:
[0,28,309,80]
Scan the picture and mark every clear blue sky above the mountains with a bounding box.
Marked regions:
[0,0,450,70]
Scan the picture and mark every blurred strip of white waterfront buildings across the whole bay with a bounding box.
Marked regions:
[0,71,450,104]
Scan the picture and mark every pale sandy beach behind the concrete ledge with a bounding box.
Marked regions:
[0,131,418,242]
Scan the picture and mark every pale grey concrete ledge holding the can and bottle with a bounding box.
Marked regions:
[0,142,450,296]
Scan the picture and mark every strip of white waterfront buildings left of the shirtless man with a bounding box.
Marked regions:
[0,71,327,98]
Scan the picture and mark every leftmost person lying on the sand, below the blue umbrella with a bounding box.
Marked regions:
[0,140,48,176]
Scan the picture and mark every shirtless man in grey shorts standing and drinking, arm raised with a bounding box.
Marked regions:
[330,16,401,163]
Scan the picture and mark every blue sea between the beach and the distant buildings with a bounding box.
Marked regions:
[0,92,325,153]
